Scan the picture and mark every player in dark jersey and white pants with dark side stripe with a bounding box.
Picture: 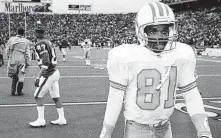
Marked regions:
[29,28,67,127]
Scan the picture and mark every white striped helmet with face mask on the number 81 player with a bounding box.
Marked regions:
[135,2,177,52]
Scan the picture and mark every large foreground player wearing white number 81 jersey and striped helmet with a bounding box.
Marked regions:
[100,2,212,138]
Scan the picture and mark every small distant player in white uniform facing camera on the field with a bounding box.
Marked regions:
[82,39,92,65]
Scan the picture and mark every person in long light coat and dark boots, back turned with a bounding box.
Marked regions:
[6,28,30,96]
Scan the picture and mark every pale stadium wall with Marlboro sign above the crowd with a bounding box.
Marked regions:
[0,0,159,14]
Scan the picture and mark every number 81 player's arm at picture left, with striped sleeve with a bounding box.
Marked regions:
[100,52,127,138]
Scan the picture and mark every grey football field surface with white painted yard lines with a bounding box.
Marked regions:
[0,47,221,138]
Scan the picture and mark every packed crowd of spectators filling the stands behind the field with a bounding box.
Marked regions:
[0,7,221,46]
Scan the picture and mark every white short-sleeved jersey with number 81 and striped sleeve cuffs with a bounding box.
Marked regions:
[107,42,196,124]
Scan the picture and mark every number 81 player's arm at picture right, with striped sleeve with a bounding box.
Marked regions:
[179,49,212,138]
